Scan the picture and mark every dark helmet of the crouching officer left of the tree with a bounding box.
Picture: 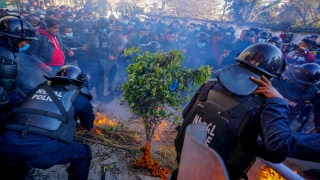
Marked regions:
[44,65,87,86]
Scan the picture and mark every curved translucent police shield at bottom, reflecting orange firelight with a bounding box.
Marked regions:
[178,123,229,180]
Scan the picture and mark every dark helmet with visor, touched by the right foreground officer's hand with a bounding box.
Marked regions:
[217,43,286,96]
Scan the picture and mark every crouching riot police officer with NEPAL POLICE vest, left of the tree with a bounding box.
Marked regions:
[0,65,94,180]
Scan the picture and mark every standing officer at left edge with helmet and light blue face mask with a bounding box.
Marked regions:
[0,15,37,120]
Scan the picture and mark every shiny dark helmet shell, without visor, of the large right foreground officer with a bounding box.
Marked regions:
[235,43,286,79]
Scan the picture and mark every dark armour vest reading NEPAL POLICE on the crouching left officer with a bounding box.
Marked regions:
[5,82,79,143]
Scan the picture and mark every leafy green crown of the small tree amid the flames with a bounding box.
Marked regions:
[122,47,211,142]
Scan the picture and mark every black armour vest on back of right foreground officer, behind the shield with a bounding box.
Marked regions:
[175,81,264,179]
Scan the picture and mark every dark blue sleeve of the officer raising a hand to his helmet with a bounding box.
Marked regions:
[261,98,320,162]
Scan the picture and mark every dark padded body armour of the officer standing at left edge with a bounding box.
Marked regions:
[0,46,18,93]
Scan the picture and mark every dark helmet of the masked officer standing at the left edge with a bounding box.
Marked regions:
[0,16,37,40]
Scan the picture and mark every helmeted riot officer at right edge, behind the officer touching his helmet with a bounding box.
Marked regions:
[274,63,320,132]
